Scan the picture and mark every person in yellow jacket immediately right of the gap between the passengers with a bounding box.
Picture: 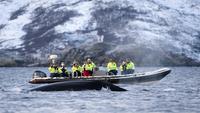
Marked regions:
[107,59,117,75]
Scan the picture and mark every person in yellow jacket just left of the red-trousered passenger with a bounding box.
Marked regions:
[72,62,82,77]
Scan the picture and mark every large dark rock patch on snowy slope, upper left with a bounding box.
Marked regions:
[23,4,78,52]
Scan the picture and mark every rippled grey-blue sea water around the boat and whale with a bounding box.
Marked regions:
[0,67,200,113]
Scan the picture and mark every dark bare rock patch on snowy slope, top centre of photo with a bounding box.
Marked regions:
[92,5,140,43]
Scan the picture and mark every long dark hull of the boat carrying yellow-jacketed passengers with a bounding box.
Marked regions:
[29,68,171,84]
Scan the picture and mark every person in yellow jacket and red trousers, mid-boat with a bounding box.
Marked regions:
[82,59,96,76]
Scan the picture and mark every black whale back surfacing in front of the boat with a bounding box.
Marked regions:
[31,80,126,91]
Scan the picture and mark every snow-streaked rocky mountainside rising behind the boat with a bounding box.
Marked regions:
[0,0,200,66]
